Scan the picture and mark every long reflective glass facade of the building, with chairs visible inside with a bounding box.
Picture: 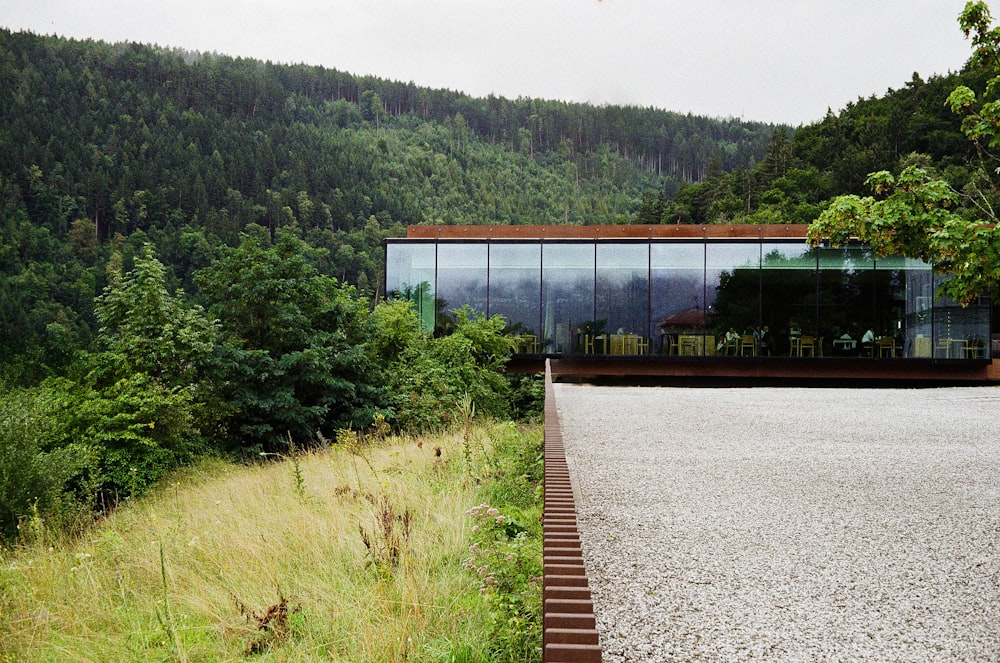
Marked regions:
[386,238,990,359]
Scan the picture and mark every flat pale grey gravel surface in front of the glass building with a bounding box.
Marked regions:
[555,384,1000,663]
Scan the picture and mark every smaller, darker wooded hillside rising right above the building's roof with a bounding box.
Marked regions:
[637,68,988,224]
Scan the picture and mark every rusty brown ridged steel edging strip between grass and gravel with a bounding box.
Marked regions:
[542,364,601,663]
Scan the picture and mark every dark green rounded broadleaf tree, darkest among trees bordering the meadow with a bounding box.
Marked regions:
[197,231,378,451]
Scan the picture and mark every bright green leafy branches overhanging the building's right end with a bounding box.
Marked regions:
[809,2,1000,304]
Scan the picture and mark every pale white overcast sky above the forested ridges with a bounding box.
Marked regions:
[0,0,971,125]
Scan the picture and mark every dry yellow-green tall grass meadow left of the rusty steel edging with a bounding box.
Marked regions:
[0,424,540,662]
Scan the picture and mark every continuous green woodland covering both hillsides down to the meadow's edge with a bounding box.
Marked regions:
[0,30,986,537]
